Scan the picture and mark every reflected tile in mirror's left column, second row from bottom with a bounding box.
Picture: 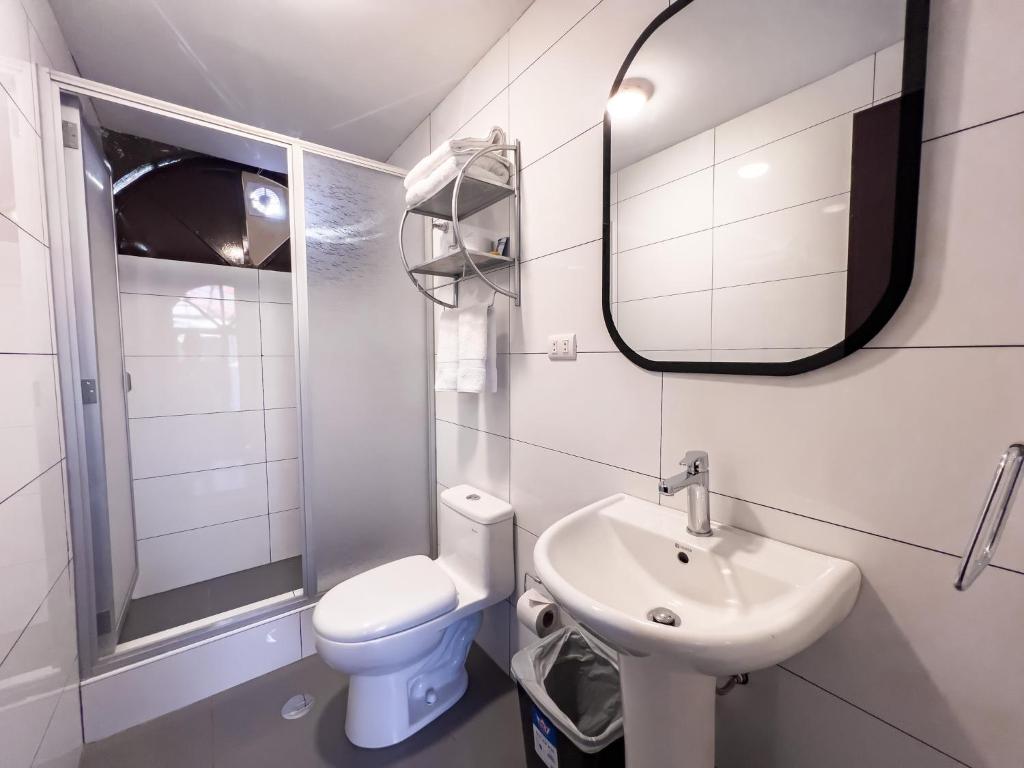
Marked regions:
[615,229,718,301]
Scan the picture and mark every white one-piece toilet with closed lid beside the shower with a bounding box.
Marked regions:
[313,485,515,748]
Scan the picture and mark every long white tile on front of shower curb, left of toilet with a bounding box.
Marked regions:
[82,613,300,741]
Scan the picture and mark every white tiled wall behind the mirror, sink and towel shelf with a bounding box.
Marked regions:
[392,0,1024,768]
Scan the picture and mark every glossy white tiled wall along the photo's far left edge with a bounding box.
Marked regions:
[0,0,82,768]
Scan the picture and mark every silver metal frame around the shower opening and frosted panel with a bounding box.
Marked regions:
[37,67,437,680]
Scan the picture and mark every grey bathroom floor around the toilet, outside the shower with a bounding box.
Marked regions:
[80,645,526,768]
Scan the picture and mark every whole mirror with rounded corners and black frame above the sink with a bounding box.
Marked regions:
[602,0,929,376]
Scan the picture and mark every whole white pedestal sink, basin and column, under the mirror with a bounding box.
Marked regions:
[534,494,860,768]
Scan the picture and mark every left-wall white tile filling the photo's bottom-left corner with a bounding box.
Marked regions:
[0,568,76,766]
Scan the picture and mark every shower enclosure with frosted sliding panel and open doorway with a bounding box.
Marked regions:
[44,74,434,678]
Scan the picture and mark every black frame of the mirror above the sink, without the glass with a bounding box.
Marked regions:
[601,0,930,376]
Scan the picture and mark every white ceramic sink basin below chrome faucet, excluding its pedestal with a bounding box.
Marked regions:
[534,494,860,675]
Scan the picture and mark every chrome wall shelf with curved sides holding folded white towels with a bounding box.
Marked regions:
[398,128,522,309]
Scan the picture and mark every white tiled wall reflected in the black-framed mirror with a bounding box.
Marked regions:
[609,43,903,361]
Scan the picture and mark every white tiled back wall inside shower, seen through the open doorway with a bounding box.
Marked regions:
[118,256,302,597]
